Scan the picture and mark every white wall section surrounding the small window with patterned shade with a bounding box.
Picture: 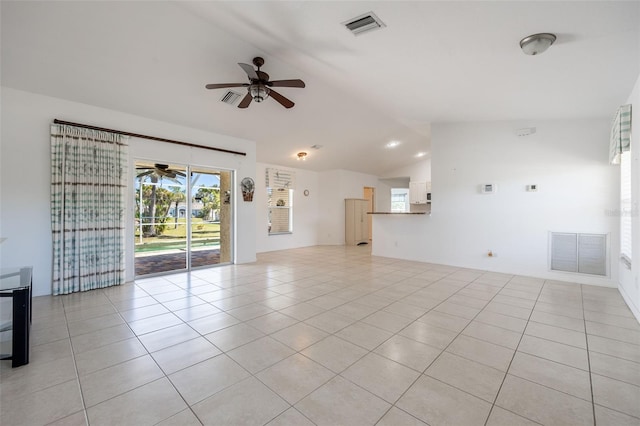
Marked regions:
[253,163,320,253]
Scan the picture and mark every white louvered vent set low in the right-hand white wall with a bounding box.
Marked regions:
[549,232,609,276]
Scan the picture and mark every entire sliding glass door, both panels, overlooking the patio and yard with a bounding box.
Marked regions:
[135,161,232,276]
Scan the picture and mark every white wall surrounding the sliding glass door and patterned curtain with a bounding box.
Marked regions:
[0,87,256,295]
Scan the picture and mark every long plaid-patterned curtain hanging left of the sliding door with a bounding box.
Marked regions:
[51,124,128,295]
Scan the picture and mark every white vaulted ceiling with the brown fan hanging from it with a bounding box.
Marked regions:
[1,0,640,175]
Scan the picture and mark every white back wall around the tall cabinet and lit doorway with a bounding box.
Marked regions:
[318,170,391,245]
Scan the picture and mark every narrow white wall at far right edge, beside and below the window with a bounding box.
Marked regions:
[615,72,640,321]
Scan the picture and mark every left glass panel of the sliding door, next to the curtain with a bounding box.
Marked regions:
[135,161,189,276]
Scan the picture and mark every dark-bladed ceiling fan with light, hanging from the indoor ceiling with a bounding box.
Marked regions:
[205,57,305,108]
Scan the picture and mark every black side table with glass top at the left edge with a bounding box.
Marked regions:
[0,266,33,368]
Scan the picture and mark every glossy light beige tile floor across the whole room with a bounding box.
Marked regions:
[0,247,640,426]
